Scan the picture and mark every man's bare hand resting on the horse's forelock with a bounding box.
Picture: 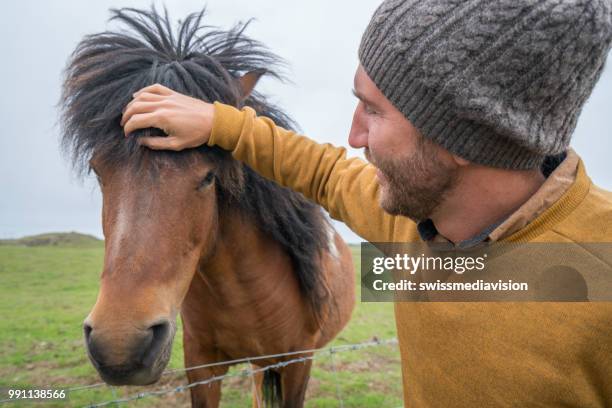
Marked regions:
[121,84,214,150]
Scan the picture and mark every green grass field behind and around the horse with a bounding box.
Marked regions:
[0,236,401,407]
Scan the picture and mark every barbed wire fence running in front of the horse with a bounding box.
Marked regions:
[0,338,397,408]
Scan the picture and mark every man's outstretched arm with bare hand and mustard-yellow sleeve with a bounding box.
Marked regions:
[121,85,412,242]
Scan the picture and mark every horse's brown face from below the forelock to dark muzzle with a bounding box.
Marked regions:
[84,148,232,384]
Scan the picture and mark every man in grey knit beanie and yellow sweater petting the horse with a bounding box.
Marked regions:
[122,0,612,407]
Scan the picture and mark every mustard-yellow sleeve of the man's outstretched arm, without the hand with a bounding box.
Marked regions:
[208,102,410,242]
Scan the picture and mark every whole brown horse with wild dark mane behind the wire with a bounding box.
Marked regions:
[61,9,354,407]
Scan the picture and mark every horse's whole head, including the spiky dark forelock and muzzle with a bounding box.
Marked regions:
[62,9,290,384]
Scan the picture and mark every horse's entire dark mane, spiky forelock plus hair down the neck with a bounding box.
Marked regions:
[60,7,328,316]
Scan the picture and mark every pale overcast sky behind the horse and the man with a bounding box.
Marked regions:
[0,0,612,242]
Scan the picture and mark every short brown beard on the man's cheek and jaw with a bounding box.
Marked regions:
[366,139,457,222]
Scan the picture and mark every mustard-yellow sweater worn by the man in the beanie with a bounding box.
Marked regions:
[208,103,612,407]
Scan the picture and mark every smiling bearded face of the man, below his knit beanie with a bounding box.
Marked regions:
[349,65,458,221]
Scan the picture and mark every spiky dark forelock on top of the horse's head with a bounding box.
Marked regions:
[60,8,292,174]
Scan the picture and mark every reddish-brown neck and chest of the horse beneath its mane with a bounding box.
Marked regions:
[182,207,318,356]
